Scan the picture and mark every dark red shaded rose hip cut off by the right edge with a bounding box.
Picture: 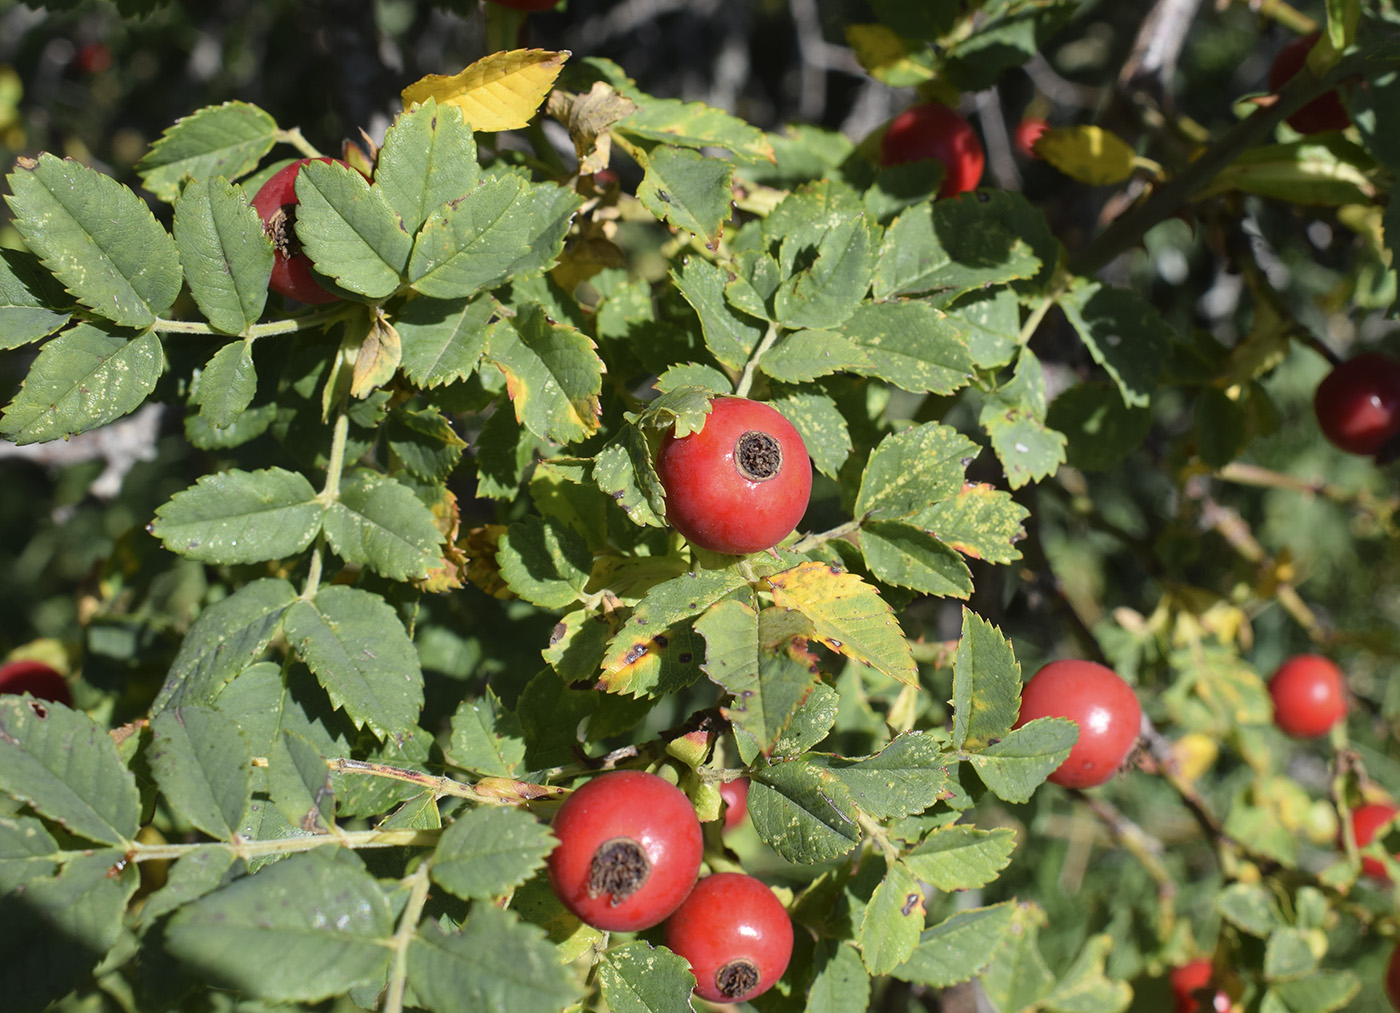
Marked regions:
[1313,351,1400,455]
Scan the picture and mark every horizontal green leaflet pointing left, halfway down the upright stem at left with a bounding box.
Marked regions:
[151,467,325,564]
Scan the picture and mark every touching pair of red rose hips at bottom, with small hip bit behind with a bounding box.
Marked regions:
[547,771,792,1002]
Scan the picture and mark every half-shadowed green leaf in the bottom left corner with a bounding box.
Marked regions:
[0,849,140,1013]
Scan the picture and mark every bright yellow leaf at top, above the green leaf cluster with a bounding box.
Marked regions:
[403,49,570,130]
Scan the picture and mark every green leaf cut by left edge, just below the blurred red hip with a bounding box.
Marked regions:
[0,694,141,844]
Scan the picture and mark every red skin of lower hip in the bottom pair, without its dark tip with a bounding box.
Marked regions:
[665,872,792,1002]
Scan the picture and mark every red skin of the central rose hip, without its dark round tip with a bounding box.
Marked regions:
[657,397,812,555]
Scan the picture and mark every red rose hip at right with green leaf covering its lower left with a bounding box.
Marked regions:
[1015,659,1142,788]
